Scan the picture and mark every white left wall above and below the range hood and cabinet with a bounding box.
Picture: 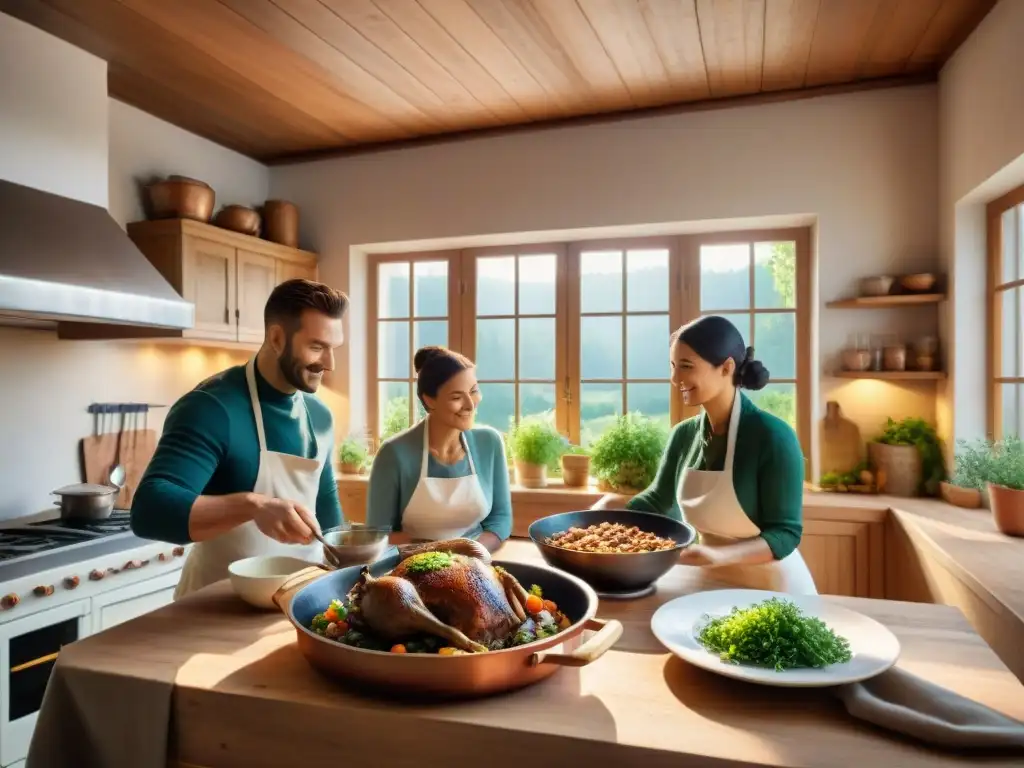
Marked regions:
[0,13,267,520]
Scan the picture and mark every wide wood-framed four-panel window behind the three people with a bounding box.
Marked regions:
[368,229,810,451]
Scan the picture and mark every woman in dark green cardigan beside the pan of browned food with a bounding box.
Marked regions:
[595,315,817,595]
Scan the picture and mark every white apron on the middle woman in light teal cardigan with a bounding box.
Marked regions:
[401,416,490,542]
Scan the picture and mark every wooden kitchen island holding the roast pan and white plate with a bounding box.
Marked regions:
[28,541,1024,768]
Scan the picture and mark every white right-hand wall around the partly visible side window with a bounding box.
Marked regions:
[938,0,1024,450]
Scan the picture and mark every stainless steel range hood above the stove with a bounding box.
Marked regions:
[0,179,196,330]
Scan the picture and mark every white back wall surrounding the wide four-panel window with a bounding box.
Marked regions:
[271,86,938,462]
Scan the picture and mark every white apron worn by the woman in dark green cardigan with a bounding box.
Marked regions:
[676,389,817,595]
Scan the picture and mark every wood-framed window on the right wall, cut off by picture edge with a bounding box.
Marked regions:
[988,186,1024,438]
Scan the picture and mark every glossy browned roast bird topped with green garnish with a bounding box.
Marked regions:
[348,539,528,652]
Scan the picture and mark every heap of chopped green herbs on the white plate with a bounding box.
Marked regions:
[698,597,852,672]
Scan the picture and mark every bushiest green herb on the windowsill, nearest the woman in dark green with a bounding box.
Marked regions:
[590,414,668,495]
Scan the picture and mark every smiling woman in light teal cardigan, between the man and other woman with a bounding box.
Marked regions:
[367,346,512,552]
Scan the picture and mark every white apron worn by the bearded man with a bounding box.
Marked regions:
[174,358,330,600]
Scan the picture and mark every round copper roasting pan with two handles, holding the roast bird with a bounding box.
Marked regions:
[273,555,623,698]
